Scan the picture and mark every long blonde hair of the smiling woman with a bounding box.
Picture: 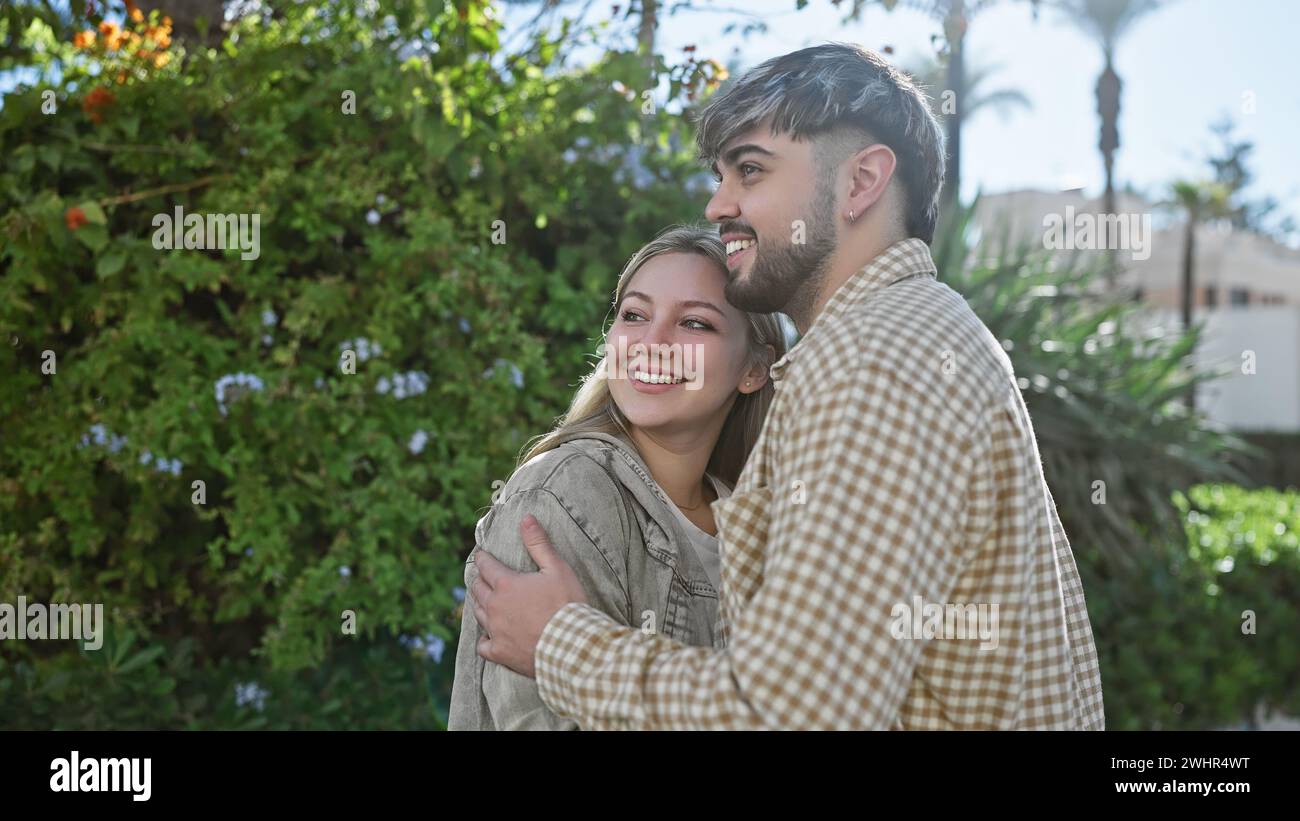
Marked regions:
[519,225,785,487]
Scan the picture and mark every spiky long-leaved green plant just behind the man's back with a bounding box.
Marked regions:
[933,196,1244,566]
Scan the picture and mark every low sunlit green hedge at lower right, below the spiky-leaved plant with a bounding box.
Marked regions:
[1088,485,1300,730]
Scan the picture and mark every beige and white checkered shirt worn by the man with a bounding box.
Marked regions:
[536,239,1105,730]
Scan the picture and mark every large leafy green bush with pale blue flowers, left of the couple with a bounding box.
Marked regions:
[0,1,709,727]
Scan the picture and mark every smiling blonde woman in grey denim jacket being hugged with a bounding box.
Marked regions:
[449,226,785,730]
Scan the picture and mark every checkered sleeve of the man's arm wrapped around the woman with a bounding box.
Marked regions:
[534,368,969,729]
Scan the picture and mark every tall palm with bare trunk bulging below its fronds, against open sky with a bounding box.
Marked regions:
[1056,0,1161,214]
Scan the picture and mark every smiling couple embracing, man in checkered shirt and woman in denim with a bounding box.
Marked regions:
[450,44,1104,730]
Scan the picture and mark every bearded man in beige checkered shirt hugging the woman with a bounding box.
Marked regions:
[472,44,1104,729]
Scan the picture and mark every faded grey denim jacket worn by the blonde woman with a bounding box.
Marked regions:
[447,433,723,730]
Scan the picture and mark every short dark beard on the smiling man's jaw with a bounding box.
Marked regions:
[725,184,836,322]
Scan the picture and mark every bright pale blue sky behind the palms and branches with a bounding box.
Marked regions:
[506,0,1300,231]
